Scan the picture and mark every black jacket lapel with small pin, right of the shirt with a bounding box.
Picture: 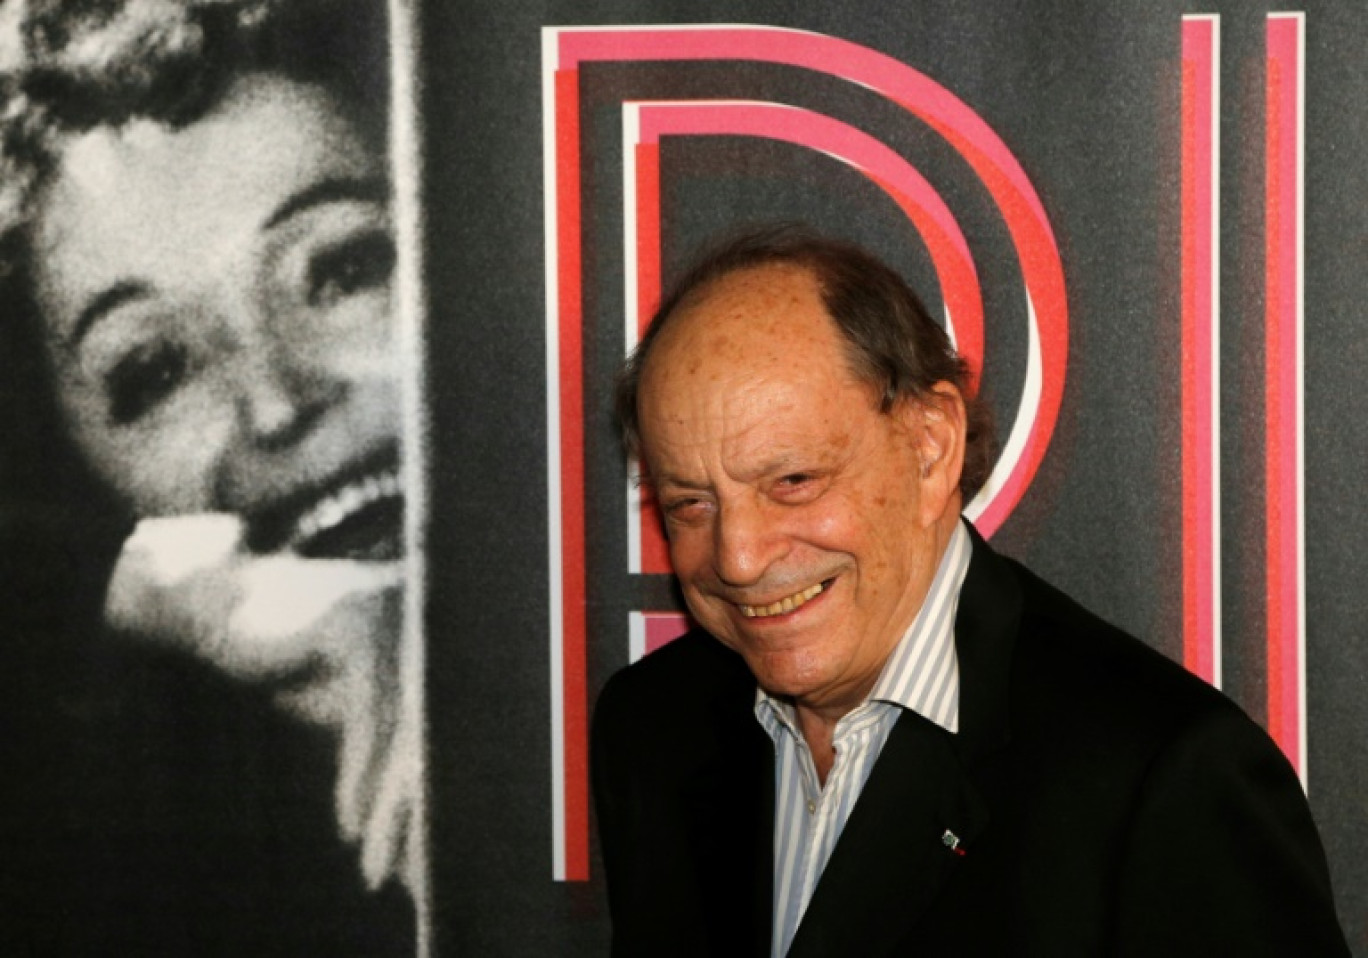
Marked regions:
[789,527,1021,958]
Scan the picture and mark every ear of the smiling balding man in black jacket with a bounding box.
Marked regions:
[895,382,966,526]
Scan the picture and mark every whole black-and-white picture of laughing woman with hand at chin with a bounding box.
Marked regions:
[0,0,420,954]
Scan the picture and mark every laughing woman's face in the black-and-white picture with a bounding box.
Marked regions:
[33,74,402,558]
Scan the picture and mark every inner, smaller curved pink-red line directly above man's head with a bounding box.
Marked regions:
[637,100,984,379]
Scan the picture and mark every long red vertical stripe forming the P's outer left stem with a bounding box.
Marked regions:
[555,70,590,881]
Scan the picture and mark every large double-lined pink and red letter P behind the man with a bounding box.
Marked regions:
[542,26,1068,880]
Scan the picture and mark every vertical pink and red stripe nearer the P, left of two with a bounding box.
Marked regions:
[1181,16,1220,683]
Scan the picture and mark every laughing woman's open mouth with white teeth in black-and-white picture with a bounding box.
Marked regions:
[248,461,404,561]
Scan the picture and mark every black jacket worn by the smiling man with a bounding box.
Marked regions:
[591,535,1347,958]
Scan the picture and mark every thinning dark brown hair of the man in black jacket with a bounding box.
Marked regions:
[614,224,995,502]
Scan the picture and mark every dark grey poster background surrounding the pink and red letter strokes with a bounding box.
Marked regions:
[423,0,1368,955]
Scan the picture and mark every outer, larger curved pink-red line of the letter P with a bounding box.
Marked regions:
[557,26,1068,535]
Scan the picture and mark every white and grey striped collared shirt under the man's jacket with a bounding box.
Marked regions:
[755,524,971,958]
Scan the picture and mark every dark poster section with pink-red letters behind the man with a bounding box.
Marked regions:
[423,0,1368,955]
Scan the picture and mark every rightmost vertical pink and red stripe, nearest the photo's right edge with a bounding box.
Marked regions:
[1264,14,1305,780]
